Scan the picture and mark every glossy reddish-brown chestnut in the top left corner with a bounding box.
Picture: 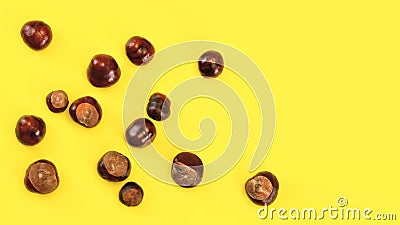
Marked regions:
[21,20,53,51]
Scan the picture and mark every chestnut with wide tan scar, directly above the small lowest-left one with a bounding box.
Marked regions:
[97,151,131,182]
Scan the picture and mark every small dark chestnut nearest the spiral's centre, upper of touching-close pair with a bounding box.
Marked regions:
[147,93,171,121]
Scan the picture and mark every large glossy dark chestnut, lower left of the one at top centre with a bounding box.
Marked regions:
[86,54,121,87]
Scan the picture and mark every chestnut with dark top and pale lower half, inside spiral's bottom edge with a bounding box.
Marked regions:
[171,152,204,188]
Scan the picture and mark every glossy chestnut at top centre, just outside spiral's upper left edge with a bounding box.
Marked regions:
[125,36,155,66]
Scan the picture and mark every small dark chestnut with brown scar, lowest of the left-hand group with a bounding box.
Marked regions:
[119,182,144,206]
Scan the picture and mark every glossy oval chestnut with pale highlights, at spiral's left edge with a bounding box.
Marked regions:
[125,118,157,148]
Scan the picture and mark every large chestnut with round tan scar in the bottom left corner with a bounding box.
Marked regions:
[24,159,60,194]
